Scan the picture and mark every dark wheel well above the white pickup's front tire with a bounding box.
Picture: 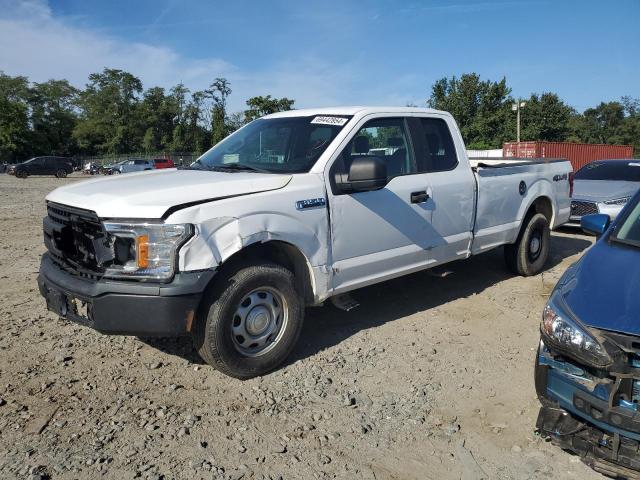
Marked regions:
[213,240,314,305]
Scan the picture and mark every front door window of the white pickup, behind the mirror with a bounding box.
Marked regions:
[341,118,415,178]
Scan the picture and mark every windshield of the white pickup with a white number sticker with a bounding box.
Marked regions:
[190,115,351,173]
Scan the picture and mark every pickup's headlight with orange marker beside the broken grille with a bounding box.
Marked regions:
[104,223,193,280]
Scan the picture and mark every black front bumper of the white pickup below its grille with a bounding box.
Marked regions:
[38,253,215,336]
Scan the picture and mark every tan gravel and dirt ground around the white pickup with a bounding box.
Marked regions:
[0,175,600,480]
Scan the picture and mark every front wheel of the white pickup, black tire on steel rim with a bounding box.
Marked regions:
[193,263,304,380]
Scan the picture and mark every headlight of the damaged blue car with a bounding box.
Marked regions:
[540,289,613,367]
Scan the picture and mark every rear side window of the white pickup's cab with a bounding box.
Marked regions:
[412,118,458,172]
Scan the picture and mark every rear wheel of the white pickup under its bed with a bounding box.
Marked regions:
[504,213,551,277]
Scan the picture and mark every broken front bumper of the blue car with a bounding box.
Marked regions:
[535,341,640,480]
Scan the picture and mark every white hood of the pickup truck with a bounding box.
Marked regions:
[47,168,291,219]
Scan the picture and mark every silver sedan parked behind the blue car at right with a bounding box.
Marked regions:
[567,160,640,227]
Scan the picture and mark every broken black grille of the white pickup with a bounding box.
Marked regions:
[43,203,113,278]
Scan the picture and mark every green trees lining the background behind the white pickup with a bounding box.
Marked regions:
[0,68,640,161]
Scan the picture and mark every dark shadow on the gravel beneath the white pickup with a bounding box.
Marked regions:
[139,234,591,370]
